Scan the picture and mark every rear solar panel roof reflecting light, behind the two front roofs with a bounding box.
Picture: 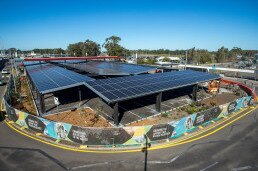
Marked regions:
[62,61,156,75]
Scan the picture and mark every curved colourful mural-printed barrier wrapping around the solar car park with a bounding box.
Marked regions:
[4,96,253,146]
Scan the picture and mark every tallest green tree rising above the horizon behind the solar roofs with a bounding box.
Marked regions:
[103,36,128,56]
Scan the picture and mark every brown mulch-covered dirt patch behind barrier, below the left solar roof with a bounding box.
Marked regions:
[44,108,111,127]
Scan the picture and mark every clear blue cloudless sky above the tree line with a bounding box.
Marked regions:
[0,0,258,50]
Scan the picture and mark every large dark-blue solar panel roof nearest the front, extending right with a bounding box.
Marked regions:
[85,70,220,103]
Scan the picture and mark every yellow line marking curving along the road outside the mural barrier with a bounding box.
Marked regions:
[4,106,258,154]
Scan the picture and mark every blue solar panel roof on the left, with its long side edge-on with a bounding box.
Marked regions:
[26,64,94,94]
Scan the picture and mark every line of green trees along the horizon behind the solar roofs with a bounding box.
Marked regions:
[6,35,258,64]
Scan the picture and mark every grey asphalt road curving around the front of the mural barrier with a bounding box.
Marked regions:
[0,82,258,171]
